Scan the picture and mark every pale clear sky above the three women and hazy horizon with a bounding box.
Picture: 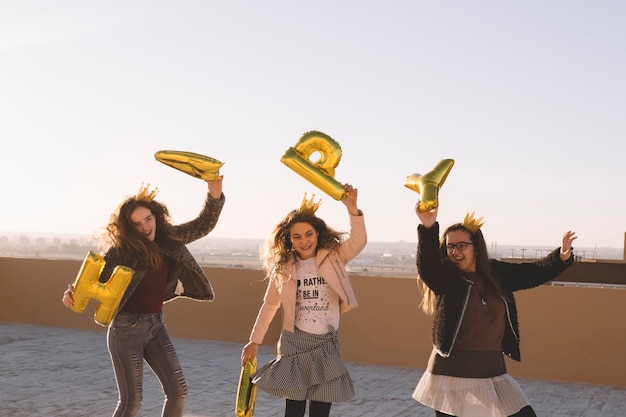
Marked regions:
[0,0,626,247]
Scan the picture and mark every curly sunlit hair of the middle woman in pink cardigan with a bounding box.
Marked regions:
[261,210,346,286]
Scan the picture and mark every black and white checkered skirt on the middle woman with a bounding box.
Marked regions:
[252,328,354,403]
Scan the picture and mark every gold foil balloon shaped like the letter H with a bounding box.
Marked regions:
[71,251,135,325]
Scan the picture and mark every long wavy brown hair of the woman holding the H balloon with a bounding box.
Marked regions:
[103,197,180,268]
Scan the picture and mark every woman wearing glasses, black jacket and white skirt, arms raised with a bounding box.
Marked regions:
[413,202,576,417]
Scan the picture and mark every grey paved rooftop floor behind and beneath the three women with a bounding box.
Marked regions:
[0,322,626,417]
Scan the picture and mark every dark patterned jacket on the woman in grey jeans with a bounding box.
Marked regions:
[100,193,226,324]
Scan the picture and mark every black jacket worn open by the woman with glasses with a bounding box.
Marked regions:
[417,223,573,361]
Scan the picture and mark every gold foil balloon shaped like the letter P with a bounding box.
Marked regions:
[280,130,346,200]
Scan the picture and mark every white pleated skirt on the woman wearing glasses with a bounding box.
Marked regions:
[413,371,530,417]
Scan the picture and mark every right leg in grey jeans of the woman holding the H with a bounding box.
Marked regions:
[144,319,187,417]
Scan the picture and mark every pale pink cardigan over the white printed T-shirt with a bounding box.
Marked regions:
[250,211,367,344]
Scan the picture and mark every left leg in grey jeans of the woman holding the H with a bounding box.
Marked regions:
[107,316,146,417]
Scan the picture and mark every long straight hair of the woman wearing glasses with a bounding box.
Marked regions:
[417,223,506,315]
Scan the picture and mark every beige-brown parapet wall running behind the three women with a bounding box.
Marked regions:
[0,258,626,387]
